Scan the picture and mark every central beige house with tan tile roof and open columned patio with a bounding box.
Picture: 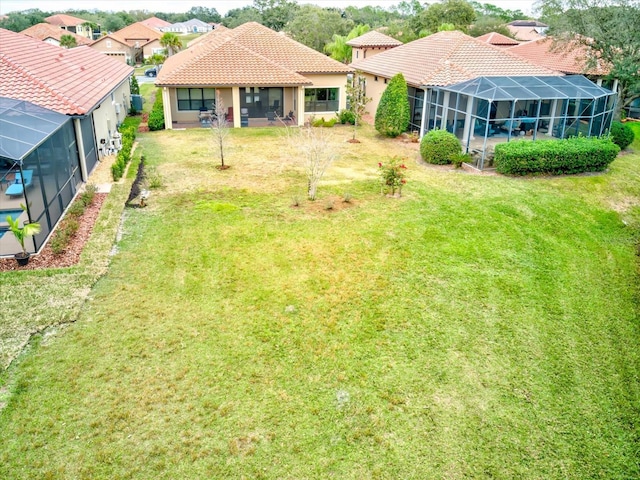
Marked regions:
[156,22,352,128]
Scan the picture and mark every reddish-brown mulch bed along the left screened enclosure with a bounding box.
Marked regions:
[0,193,107,272]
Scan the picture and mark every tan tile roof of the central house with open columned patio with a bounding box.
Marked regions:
[156,22,352,86]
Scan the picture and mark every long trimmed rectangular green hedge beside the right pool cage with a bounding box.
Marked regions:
[494,137,620,175]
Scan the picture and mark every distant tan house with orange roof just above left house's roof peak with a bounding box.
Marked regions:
[91,22,164,63]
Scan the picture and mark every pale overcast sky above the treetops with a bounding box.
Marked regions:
[0,0,535,16]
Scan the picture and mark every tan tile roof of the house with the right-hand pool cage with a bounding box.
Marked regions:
[351,31,560,86]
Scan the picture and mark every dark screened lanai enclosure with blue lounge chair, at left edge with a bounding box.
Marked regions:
[0,97,82,255]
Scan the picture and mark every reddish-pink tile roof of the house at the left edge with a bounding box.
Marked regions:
[0,28,133,115]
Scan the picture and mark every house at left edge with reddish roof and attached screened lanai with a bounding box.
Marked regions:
[0,29,133,255]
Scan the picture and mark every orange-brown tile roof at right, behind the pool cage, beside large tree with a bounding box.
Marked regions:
[509,37,610,75]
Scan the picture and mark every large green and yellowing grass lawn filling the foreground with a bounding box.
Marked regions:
[0,128,640,479]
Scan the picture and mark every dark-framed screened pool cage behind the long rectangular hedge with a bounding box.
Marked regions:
[422,75,616,169]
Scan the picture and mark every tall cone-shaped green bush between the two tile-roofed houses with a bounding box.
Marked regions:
[375,73,410,137]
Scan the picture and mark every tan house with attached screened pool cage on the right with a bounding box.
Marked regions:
[351,31,615,168]
